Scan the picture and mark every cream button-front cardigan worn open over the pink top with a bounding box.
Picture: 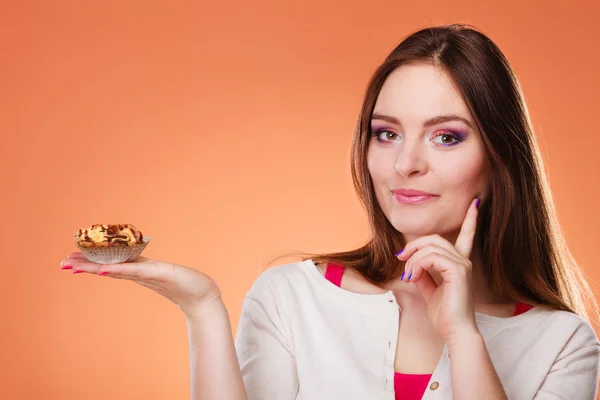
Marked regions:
[236,260,600,400]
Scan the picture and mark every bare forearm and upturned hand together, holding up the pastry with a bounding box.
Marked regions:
[61,253,248,400]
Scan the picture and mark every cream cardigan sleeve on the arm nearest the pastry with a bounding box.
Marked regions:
[236,278,298,400]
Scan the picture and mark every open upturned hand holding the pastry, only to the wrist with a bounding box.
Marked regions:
[61,252,221,318]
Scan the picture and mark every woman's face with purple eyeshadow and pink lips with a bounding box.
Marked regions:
[367,64,489,241]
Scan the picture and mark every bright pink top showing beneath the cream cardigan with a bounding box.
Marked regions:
[325,264,533,400]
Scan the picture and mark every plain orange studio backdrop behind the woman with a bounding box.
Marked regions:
[0,0,600,400]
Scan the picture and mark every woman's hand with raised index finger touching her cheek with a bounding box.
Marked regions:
[398,199,479,344]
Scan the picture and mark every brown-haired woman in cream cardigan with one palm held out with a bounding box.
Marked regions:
[62,25,600,400]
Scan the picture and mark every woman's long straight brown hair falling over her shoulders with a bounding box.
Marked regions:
[270,25,598,319]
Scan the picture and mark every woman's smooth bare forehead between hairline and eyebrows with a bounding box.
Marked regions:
[374,64,472,120]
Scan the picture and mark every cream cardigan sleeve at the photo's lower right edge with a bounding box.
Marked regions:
[534,323,600,400]
